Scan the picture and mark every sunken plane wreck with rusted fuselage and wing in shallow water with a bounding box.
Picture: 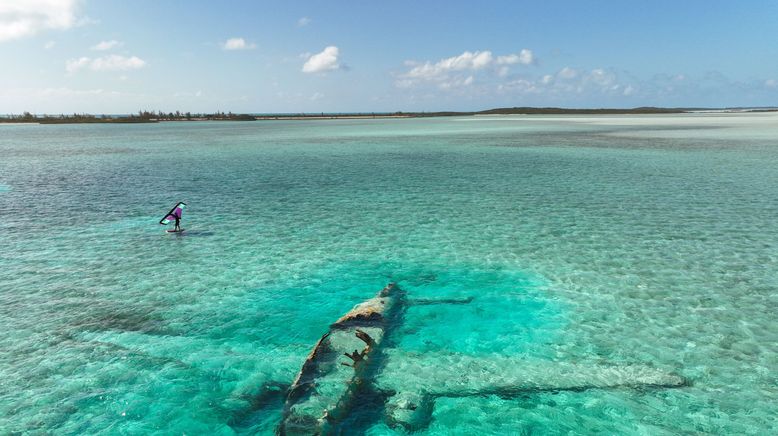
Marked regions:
[277,284,688,435]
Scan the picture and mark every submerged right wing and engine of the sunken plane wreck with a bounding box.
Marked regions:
[374,350,689,431]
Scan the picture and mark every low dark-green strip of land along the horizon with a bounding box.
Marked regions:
[0,107,778,124]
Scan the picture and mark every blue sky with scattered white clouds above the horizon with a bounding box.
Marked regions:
[0,0,778,113]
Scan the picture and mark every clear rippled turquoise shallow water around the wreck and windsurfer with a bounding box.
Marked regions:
[0,114,778,435]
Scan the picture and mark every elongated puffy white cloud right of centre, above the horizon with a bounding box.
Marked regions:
[396,49,535,89]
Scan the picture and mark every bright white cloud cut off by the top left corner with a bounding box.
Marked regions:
[0,0,80,42]
